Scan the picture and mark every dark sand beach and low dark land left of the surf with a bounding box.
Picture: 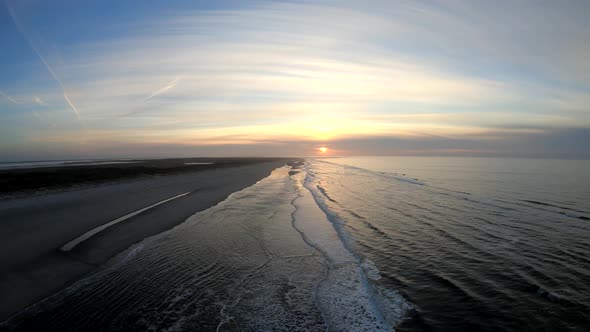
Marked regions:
[0,159,292,321]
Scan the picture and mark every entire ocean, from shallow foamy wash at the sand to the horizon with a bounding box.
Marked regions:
[2,157,590,331]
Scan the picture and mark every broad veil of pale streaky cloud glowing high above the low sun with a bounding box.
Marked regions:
[1,1,590,160]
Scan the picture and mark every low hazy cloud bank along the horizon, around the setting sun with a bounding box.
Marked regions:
[11,129,590,159]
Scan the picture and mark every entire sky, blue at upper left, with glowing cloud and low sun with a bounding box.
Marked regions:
[0,0,590,161]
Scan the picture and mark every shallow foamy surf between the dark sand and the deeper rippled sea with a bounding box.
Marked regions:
[0,162,412,331]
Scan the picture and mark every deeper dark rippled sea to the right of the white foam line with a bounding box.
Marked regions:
[308,158,590,331]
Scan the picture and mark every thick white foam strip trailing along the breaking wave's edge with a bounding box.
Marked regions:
[293,172,408,331]
